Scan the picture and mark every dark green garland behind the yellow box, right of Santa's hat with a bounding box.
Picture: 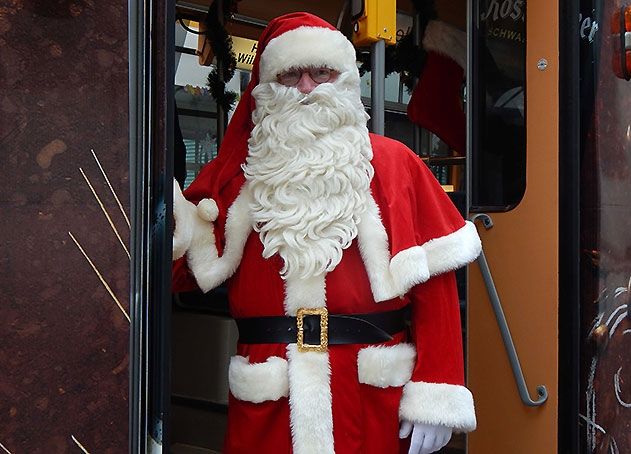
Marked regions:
[359,0,437,92]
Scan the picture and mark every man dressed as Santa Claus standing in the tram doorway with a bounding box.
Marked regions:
[173,13,480,454]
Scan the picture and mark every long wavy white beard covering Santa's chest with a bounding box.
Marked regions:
[243,74,374,279]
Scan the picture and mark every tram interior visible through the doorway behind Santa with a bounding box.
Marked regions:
[167,0,467,454]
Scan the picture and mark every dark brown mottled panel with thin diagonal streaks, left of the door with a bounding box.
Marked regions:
[0,0,130,454]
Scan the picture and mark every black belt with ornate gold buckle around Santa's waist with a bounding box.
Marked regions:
[236,308,407,351]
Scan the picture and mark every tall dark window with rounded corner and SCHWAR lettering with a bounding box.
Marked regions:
[471,0,526,211]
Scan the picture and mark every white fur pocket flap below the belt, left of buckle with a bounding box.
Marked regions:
[228,355,289,404]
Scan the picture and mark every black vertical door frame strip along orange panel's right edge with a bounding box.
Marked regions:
[558,0,581,453]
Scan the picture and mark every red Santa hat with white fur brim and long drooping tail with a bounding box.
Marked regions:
[186,12,359,206]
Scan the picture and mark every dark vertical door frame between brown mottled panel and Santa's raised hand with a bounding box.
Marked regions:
[128,0,175,454]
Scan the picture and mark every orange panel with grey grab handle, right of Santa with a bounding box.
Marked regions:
[468,0,559,454]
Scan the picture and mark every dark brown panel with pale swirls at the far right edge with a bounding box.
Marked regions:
[580,0,631,454]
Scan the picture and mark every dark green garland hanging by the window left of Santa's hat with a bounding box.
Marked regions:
[206,0,237,112]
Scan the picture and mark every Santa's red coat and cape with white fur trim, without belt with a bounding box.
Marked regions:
[173,135,480,454]
